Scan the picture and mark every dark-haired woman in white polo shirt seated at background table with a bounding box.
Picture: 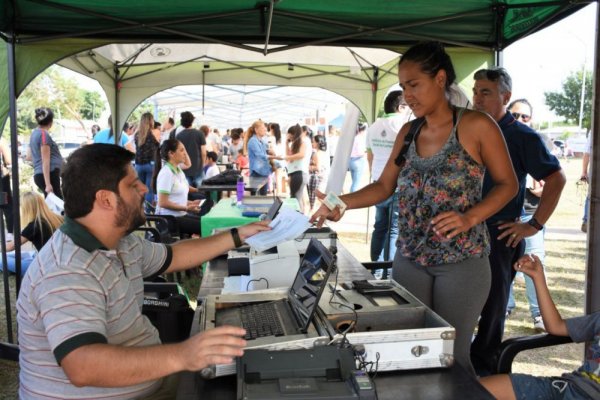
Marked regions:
[155,139,200,235]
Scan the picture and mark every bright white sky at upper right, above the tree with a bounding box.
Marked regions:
[504,3,596,121]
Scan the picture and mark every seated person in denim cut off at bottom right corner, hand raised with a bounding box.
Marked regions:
[480,255,600,399]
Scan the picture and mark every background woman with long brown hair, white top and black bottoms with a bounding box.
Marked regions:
[283,124,312,212]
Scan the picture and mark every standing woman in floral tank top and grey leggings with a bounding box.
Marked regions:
[312,42,517,374]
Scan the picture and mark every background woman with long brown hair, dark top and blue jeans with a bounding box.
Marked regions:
[134,113,160,209]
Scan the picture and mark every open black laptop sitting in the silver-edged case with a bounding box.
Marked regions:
[215,239,334,345]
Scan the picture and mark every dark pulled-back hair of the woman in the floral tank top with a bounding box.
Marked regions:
[398,42,456,92]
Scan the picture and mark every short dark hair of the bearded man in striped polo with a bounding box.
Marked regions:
[61,143,135,218]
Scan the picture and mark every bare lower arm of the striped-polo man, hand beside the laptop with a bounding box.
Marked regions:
[61,326,246,387]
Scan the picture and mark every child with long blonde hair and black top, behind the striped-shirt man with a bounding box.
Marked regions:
[6,192,63,276]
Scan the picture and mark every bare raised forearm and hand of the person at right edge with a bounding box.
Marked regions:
[515,254,569,336]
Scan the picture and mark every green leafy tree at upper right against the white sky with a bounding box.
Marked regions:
[544,71,593,131]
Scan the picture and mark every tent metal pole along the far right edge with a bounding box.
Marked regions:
[585,1,600,314]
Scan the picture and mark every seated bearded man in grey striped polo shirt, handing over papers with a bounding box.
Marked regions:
[17,144,269,400]
